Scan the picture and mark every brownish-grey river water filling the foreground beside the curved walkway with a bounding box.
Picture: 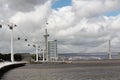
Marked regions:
[1,64,120,80]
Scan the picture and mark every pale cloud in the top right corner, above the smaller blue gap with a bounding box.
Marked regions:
[72,0,120,17]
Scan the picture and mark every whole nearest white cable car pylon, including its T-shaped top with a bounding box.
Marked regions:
[8,24,17,62]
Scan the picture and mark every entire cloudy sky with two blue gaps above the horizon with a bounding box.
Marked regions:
[0,0,120,53]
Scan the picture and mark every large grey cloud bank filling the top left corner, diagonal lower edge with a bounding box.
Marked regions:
[0,0,52,21]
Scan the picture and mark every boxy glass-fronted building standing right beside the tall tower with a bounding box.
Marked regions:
[48,40,58,61]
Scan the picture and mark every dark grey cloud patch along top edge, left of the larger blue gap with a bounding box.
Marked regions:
[3,0,48,12]
